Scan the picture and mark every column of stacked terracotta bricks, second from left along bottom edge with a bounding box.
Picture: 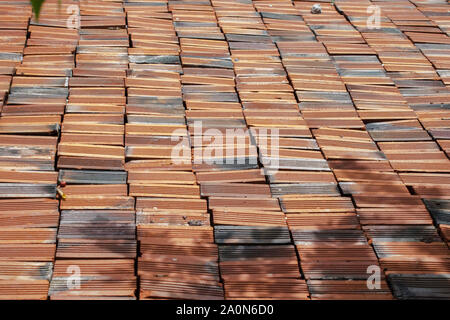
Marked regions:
[46,0,136,299]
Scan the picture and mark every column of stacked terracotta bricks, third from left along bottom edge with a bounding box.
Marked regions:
[125,1,223,299]
